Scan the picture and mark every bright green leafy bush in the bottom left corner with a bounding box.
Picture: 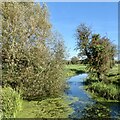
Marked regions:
[1,87,22,118]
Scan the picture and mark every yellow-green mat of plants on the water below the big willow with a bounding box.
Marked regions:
[17,97,73,118]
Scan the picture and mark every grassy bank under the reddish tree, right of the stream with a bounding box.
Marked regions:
[85,65,120,102]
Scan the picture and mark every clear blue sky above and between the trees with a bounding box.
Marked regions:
[44,2,118,58]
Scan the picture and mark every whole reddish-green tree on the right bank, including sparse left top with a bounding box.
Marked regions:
[76,24,115,80]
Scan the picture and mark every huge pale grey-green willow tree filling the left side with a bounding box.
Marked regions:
[2,2,65,99]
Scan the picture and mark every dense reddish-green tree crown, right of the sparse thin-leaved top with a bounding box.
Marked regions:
[88,34,115,79]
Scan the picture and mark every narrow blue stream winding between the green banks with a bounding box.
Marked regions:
[65,74,120,120]
